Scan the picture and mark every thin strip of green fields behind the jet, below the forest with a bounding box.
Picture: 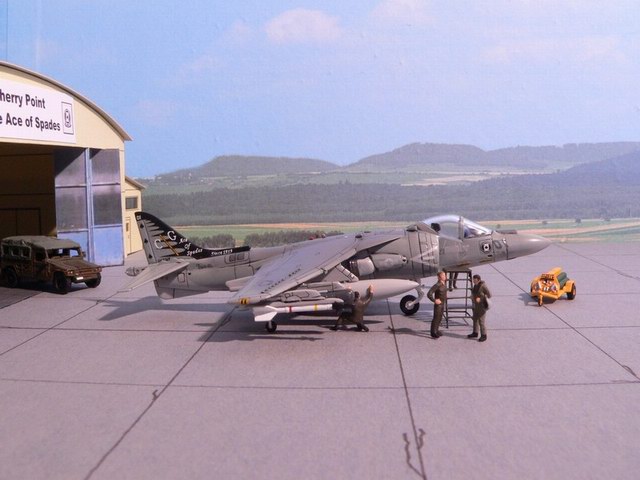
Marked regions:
[176,218,640,245]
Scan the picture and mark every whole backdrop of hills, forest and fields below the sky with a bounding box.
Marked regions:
[144,142,640,246]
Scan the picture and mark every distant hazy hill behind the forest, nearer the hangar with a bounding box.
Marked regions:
[156,155,340,184]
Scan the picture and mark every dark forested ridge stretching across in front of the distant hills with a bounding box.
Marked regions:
[143,146,640,225]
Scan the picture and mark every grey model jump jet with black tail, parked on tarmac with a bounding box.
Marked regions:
[121,212,550,332]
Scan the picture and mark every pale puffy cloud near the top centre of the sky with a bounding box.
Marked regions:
[264,8,343,44]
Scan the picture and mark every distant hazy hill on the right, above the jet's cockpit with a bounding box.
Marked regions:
[346,142,640,171]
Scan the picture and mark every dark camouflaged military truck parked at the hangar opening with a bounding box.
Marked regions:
[0,236,102,294]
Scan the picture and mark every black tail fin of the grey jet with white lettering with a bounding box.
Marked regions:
[136,212,250,264]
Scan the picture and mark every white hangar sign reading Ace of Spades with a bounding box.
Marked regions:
[0,79,76,143]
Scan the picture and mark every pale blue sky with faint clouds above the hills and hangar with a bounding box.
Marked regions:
[0,0,640,177]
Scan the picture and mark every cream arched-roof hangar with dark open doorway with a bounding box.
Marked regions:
[0,61,132,266]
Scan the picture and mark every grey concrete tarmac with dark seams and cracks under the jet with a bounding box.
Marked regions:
[0,243,640,480]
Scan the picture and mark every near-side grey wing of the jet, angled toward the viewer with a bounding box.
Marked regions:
[228,234,400,305]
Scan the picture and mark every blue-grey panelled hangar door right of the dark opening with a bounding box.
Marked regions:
[54,148,124,266]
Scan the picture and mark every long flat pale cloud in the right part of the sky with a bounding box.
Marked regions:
[482,36,628,64]
